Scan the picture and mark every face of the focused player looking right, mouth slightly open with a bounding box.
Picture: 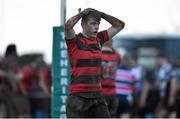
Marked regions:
[82,18,100,39]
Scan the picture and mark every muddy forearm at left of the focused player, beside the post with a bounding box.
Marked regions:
[65,12,83,30]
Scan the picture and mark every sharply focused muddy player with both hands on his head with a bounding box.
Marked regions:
[65,8,125,118]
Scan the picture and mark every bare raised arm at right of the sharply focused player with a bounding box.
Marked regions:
[100,12,125,39]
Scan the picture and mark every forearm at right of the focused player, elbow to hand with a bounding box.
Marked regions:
[100,12,125,28]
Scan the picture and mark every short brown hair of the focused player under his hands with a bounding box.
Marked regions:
[82,11,101,23]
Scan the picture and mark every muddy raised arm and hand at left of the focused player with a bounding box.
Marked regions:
[65,8,92,39]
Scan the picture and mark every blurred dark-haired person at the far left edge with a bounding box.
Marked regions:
[0,44,28,118]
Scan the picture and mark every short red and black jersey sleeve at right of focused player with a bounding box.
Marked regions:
[97,30,109,46]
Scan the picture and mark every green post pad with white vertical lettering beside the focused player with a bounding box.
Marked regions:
[51,26,70,118]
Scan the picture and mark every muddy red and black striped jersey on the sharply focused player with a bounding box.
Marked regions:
[66,30,109,98]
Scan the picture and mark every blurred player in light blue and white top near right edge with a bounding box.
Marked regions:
[157,52,177,117]
